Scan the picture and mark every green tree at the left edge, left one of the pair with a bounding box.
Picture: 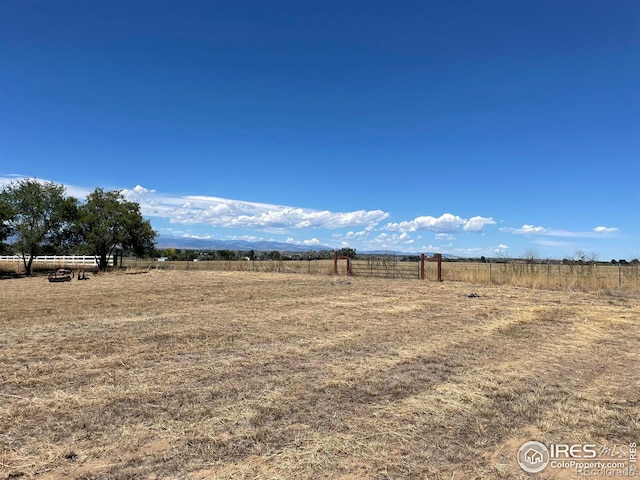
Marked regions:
[0,178,78,275]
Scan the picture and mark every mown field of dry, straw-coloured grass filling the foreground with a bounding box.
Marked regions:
[0,270,640,480]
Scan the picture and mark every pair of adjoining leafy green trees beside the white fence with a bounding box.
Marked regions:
[0,178,158,275]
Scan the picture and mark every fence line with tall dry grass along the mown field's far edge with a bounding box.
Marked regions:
[0,255,640,291]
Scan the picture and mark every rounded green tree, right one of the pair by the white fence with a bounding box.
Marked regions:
[79,188,158,270]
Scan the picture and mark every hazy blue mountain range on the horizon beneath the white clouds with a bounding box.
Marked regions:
[156,236,444,257]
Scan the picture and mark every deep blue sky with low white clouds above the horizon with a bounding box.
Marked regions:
[0,0,640,260]
